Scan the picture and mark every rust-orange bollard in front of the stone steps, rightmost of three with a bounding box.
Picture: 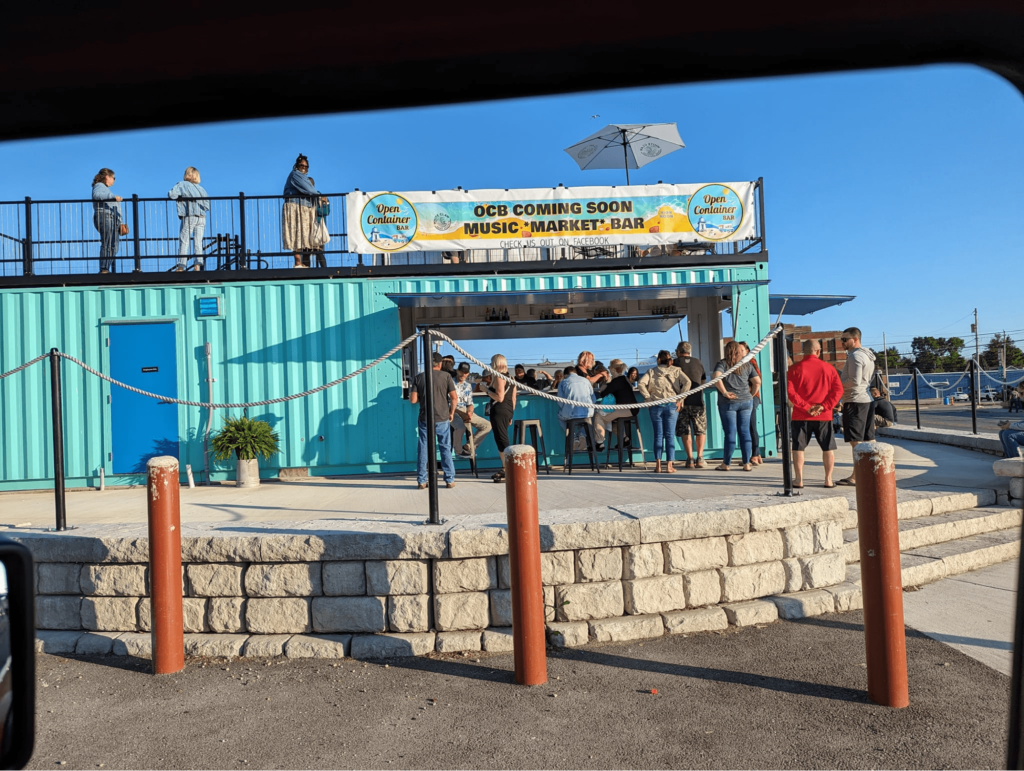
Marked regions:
[853,441,910,708]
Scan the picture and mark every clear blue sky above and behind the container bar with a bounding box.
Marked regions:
[0,66,1024,360]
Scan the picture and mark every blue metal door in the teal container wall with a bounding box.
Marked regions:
[110,323,178,474]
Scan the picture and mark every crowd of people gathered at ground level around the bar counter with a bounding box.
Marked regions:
[412,327,921,488]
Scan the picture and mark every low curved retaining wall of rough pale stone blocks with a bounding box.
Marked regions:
[25,496,849,658]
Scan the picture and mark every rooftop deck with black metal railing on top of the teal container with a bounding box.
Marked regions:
[0,183,768,287]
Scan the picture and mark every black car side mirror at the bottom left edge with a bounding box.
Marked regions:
[0,539,36,771]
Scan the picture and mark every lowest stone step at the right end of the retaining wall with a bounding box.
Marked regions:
[834,528,1021,590]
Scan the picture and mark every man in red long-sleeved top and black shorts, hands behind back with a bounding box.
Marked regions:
[788,340,843,487]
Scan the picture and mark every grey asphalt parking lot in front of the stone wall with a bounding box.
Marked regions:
[24,612,1010,771]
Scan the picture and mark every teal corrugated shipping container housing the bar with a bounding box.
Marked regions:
[0,262,776,489]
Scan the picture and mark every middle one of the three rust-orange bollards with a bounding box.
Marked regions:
[505,444,548,685]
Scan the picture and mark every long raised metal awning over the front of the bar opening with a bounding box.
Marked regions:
[385,281,770,309]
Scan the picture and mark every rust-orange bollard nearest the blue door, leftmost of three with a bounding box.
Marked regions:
[146,456,185,675]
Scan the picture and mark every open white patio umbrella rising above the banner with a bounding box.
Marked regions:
[565,123,686,184]
